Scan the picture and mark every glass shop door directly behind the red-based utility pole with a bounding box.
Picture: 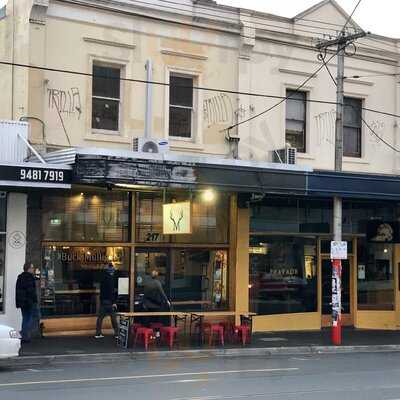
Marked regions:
[321,257,353,326]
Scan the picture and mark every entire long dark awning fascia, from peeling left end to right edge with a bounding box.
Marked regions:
[73,154,400,200]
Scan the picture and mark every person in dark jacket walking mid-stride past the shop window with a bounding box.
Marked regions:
[95,263,118,339]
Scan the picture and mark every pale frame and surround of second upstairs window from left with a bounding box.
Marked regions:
[164,66,203,144]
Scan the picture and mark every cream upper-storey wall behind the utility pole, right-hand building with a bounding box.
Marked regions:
[244,23,398,174]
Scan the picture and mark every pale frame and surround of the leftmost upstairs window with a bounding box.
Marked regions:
[88,57,128,136]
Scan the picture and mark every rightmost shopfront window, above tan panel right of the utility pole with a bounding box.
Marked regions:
[357,240,394,310]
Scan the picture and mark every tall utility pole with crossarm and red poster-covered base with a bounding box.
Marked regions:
[316,30,366,345]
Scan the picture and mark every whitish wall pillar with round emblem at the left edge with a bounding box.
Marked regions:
[0,193,27,330]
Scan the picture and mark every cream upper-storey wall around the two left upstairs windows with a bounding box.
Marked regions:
[31,4,237,157]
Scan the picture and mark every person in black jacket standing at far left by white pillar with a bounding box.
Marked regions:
[15,261,38,342]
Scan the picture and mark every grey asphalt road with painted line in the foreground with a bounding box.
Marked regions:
[0,353,400,400]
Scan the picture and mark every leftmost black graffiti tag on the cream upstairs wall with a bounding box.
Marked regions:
[47,87,82,119]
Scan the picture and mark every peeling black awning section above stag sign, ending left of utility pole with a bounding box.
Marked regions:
[74,154,307,195]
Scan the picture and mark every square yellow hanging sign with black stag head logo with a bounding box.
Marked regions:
[163,201,192,235]
